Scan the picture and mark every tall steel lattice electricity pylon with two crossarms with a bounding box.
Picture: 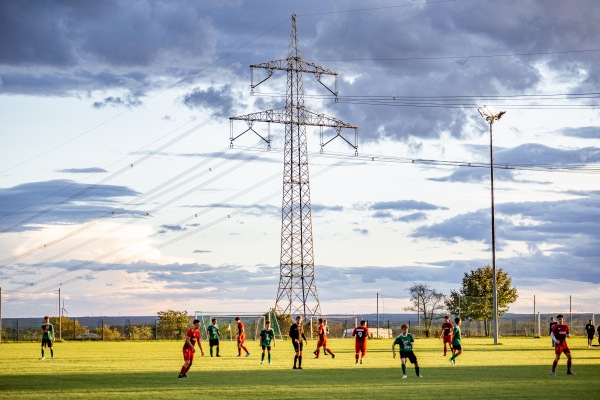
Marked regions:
[229,14,358,317]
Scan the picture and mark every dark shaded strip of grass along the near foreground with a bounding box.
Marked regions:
[0,363,600,399]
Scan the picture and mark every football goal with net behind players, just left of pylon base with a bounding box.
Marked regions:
[195,311,281,341]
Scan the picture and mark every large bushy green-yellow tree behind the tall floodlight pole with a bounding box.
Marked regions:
[446,265,519,336]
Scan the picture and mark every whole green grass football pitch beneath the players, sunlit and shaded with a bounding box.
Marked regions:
[0,338,600,399]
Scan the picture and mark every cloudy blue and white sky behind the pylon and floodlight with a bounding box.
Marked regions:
[0,0,600,318]
